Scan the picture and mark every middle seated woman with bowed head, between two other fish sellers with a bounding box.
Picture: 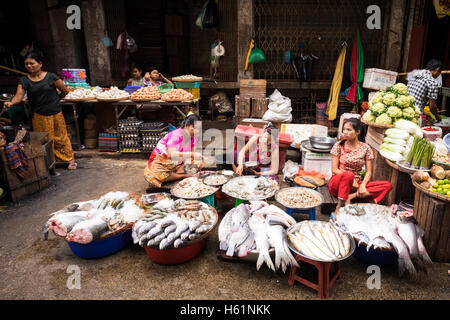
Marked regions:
[233,122,280,180]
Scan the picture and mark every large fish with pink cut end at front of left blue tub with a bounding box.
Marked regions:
[66,218,108,244]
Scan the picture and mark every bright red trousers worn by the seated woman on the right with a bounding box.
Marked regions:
[328,171,392,203]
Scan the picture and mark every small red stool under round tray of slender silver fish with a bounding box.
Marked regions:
[288,254,341,299]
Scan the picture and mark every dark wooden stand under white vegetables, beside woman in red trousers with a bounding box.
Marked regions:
[385,159,415,206]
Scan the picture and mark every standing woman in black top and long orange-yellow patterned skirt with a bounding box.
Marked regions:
[4,50,77,170]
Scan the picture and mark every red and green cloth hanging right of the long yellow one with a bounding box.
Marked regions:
[346,31,364,104]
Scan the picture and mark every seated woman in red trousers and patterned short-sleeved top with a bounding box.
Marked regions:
[328,118,392,220]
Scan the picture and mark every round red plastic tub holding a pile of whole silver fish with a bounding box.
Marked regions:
[144,238,206,265]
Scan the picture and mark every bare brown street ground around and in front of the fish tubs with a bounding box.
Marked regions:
[0,157,450,300]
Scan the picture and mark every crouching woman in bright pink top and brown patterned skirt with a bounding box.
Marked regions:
[144,114,203,188]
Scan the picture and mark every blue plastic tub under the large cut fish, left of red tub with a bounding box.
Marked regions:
[67,229,132,259]
